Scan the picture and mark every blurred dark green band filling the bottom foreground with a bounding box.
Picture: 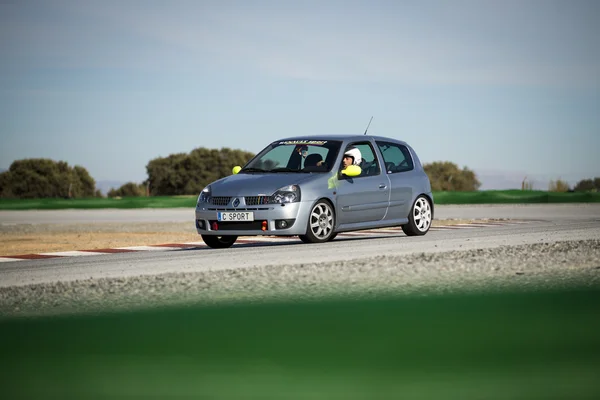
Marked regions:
[0,289,600,400]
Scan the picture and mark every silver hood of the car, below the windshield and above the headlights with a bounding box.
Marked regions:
[210,173,323,196]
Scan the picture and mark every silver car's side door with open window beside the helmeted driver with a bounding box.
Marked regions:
[336,142,390,224]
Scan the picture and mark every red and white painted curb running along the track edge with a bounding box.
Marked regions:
[0,220,534,263]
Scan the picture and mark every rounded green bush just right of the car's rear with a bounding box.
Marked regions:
[423,161,481,191]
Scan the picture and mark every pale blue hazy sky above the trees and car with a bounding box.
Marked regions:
[0,0,600,190]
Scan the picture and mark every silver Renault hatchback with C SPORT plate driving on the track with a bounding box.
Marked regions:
[196,135,433,248]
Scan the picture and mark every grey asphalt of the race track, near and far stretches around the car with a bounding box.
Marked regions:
[0,204,600,287]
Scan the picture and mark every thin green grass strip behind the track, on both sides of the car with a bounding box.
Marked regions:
[0,190,600,210]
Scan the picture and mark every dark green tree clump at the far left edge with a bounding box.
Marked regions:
[0,158,98,199]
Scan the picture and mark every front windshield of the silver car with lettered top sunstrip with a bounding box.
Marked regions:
[240,140,342,173]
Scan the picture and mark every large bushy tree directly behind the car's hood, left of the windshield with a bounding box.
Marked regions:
[146,147,254,196]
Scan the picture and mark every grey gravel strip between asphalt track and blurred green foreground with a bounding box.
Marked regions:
[0,240,600,316]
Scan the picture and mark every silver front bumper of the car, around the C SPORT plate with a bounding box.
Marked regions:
[196,201,312,236]
